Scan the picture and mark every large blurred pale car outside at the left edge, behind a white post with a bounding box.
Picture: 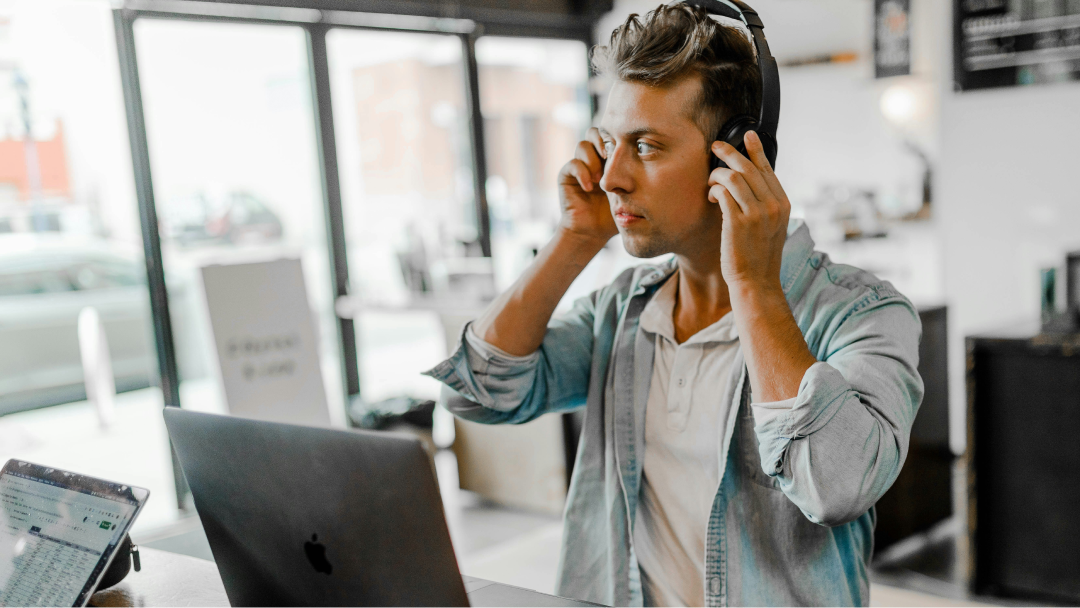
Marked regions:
[0,233,170,415]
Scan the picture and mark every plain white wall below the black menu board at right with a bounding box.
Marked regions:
[921,2,1080,450]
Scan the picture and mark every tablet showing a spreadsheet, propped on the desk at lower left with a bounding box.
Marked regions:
[0,459,150,608]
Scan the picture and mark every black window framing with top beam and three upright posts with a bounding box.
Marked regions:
[113,0,611,509]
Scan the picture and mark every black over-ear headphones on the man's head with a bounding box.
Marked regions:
[685,0,780,168]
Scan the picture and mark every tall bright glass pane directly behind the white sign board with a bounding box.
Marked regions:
[134,18,343,414]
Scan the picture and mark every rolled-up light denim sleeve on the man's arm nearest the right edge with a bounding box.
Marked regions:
[755,297,923,526]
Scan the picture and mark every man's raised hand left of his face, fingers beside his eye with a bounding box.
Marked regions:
[558,126,619,246]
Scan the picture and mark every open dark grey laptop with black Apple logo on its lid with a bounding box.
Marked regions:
[165,407,613,608]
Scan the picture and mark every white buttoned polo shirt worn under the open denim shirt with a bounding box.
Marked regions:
[633,273,795,608]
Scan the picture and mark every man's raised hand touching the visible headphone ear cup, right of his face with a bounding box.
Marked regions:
[708,131,792,289]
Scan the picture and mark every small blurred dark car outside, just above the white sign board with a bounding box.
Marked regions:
[160,191,283,245]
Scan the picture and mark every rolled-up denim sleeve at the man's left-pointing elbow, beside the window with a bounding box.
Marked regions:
[424,292,598,423]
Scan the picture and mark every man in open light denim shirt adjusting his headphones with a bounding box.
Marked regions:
[429,5,922,608]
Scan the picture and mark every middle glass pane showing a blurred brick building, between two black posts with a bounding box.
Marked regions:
[326,29,479,402]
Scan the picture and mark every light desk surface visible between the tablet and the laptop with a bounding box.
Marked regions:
[90,548,229,608]
